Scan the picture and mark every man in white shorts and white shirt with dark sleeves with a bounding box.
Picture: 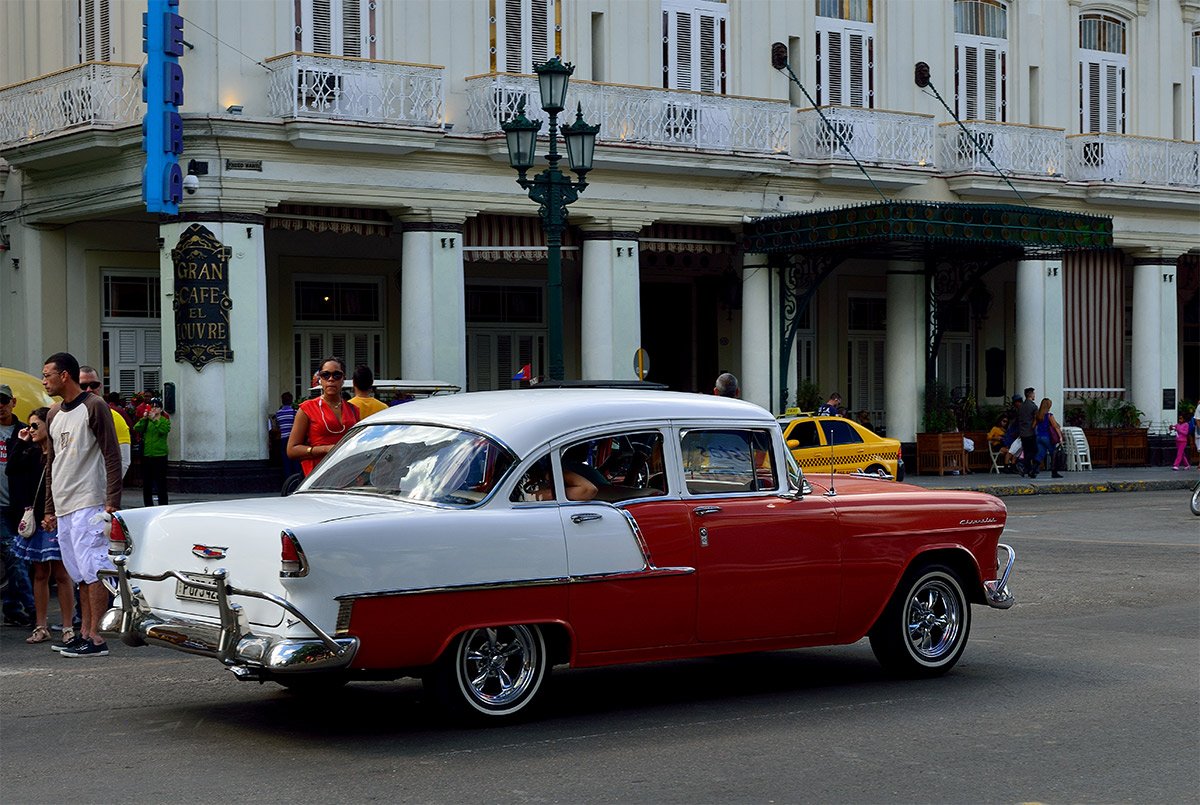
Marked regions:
[42,353,121,657]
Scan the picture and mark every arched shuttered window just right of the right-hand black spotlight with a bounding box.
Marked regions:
[954,0,1008,122]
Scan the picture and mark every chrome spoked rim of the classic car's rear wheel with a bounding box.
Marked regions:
[460,626,540,708]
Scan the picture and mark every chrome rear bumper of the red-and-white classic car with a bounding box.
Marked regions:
[100,557,359,680]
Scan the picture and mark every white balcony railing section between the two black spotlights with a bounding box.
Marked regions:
[793,107,936,167]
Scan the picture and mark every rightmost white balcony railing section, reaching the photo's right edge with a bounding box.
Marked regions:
[1067,134,1200,187]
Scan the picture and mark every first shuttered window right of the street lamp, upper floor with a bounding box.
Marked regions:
[662,0,728,94]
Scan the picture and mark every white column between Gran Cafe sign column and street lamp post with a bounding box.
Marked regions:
[400,222,467,388]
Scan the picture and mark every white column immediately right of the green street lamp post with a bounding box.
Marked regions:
[580,229,643,380]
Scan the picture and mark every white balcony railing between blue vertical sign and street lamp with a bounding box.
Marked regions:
[266,53,445,128]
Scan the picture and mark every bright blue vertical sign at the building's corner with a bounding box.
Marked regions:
[142,0,184,215]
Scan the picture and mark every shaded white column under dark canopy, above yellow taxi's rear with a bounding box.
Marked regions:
[883,262,929,441]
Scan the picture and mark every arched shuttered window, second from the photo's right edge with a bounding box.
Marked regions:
[1079,14,1129,134]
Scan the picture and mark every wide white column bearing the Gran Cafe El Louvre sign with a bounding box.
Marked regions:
[158,214,269,475]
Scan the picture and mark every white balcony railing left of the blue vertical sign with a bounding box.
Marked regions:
[0,61,142,146]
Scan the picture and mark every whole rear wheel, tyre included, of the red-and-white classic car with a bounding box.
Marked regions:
[427,625,550,721]
